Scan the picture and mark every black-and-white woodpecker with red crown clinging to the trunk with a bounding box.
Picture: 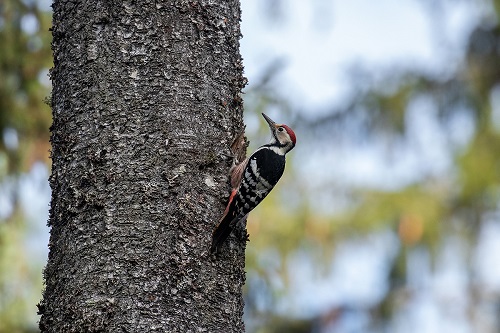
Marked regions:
[210,113,296,253]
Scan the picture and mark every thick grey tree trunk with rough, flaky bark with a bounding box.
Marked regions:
[38,0,245,333]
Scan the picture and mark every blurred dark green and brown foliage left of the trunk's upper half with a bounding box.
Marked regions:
[0,0,52,173]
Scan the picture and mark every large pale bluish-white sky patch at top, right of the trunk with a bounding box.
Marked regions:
[241,0,479,110]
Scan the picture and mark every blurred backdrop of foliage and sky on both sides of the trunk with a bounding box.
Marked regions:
[0,0,500,333]
